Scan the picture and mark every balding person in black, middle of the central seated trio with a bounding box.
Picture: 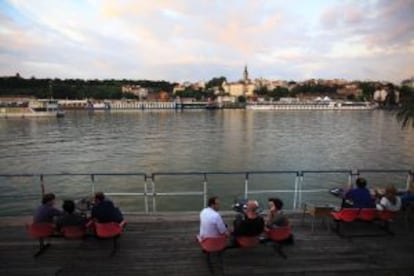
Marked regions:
[232,200,265,237]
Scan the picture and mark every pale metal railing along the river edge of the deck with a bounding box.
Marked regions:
[0,169,414,213]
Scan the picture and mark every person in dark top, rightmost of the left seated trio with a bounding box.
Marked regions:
[91,192,124,223]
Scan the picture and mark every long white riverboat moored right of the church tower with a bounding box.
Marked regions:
[246,101,375,110]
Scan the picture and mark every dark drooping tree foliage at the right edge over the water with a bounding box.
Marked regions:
[396,86,414,128]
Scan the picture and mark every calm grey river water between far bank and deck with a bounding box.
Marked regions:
[0,110,414,214]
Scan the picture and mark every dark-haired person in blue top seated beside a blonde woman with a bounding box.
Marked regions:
[343,177,375,208]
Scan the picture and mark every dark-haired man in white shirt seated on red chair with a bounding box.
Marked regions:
[199,197,230,239]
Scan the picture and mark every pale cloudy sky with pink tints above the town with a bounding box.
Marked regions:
[0,0,414,84]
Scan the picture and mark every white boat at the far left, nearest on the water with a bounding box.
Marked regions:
[0,99,65,118]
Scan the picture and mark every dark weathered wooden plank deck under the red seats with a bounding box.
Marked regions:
[0,214,414,276]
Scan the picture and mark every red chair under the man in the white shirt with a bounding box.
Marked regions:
[196,235,227,274]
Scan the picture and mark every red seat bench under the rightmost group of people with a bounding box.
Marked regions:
[331,208,397,236]
